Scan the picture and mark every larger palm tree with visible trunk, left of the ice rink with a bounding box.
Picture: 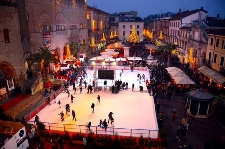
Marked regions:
[28,47,59,82]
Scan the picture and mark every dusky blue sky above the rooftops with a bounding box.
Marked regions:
[87,0,225,18]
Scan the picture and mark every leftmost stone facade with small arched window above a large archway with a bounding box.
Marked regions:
[0,3,25,88]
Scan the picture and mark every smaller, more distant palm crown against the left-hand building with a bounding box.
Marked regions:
[70,41,86,59]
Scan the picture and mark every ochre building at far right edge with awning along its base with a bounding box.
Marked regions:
[198,30,225,87]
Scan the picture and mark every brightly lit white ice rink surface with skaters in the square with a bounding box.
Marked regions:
[31,70,158,138]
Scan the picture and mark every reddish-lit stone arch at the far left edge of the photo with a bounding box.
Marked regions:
[0,61,16,79]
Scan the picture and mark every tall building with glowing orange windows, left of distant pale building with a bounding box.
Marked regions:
[87,6,110,49]
